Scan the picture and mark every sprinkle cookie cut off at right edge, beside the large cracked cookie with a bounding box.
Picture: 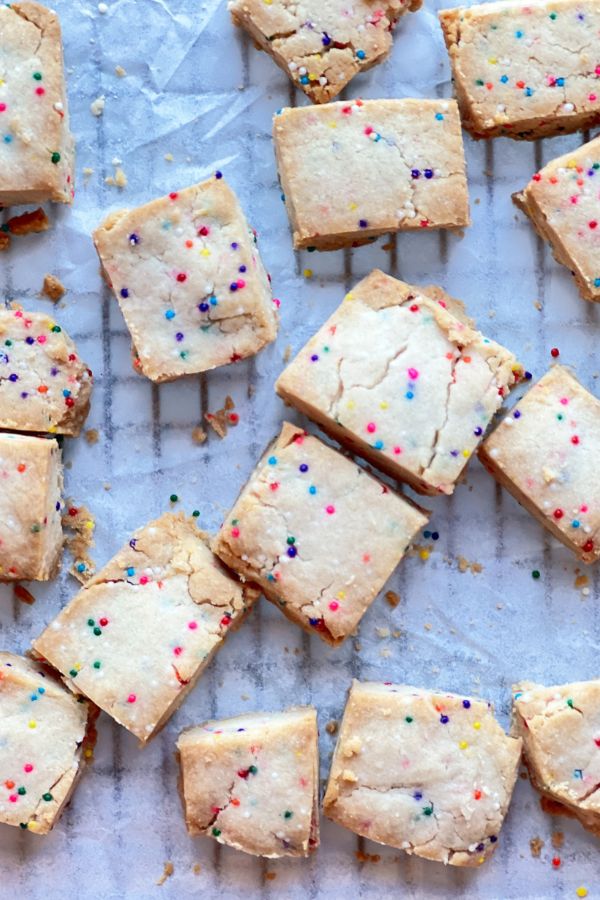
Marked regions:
[479,366,600,563]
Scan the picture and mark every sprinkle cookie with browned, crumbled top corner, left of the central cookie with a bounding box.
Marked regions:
[33,513,257,742]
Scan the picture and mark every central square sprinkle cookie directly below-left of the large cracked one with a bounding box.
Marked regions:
[212,422,427,644]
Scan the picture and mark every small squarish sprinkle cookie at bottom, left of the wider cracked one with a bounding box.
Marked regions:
[177,707,319,858]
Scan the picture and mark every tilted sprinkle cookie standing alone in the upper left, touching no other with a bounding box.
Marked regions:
[94,172,278,381]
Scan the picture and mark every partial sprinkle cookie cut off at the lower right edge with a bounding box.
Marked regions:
[513,680,600,836]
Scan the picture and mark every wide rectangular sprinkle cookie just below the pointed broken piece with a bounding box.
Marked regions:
[273,100,469,250]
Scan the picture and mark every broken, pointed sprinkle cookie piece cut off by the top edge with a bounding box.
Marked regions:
[229,0,421,103]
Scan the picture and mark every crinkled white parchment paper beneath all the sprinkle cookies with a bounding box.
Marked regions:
[0,0,600,900]
